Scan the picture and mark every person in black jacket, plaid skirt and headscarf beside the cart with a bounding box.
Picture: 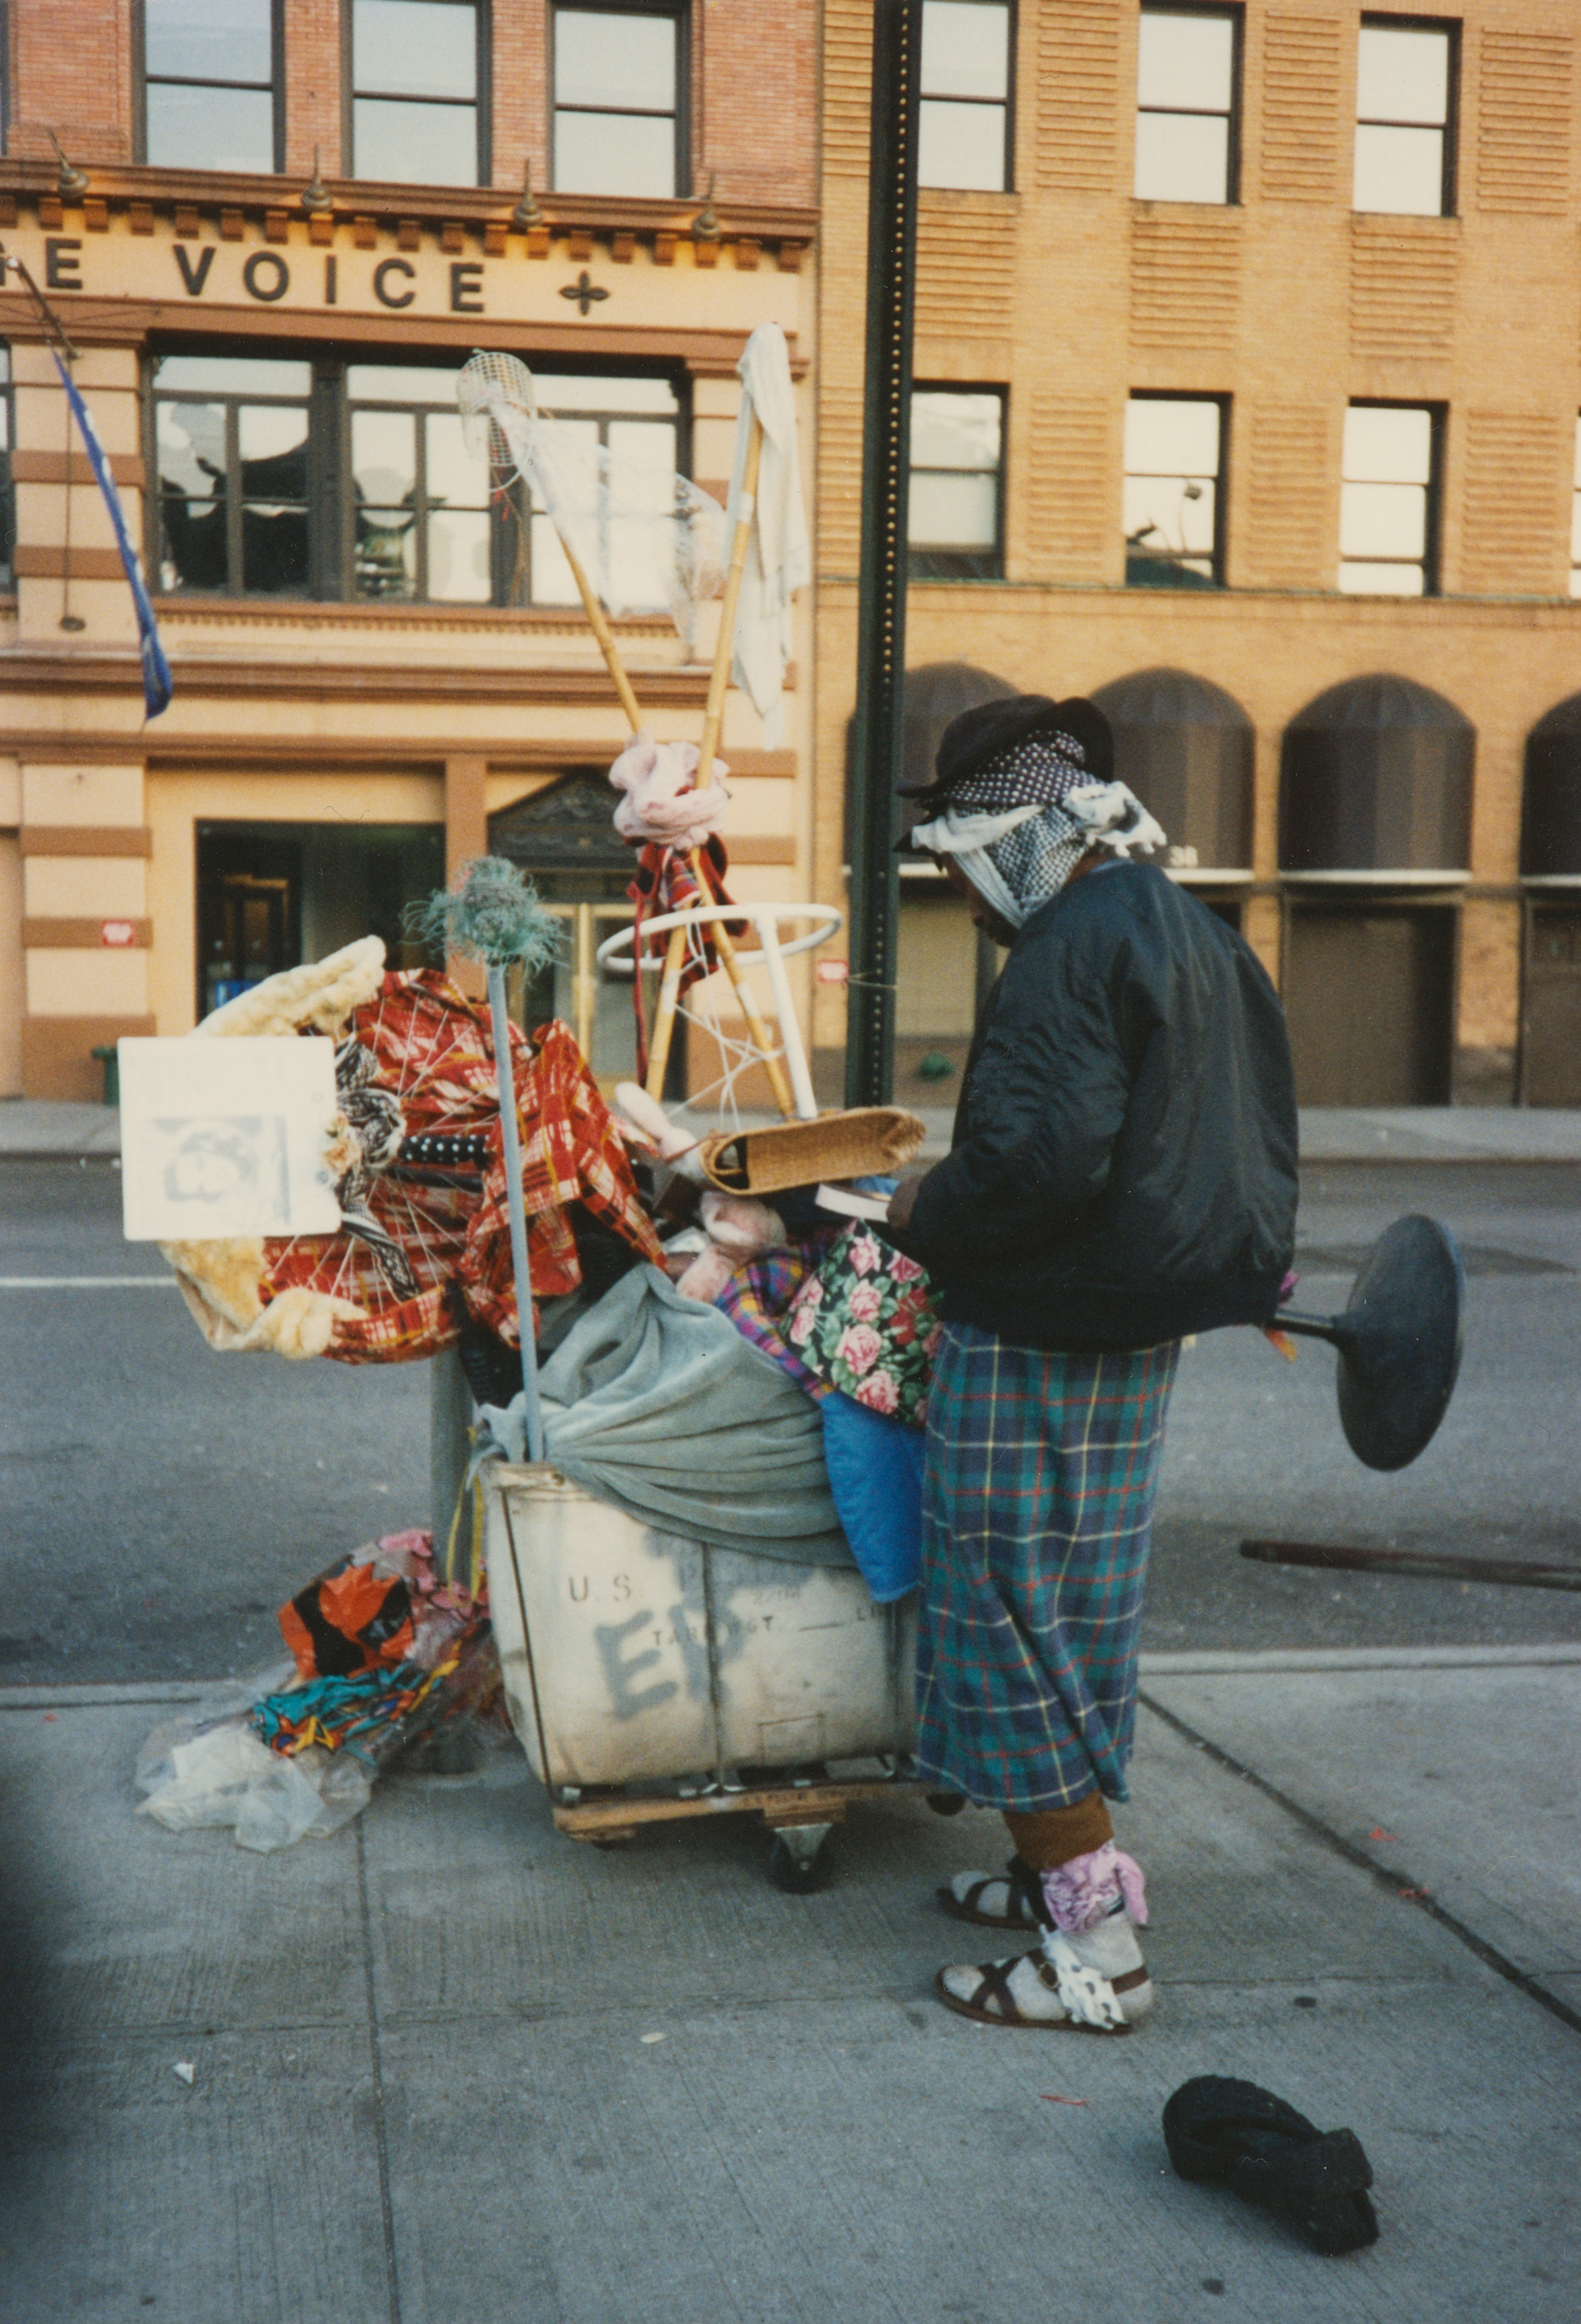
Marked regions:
[890,695,1295,2031]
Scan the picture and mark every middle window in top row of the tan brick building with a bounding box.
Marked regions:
[1134,7,1242,202]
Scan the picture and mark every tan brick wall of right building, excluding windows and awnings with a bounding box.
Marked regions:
[818,0,1581,1088]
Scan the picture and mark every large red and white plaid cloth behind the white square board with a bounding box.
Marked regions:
[258,969,662,1364]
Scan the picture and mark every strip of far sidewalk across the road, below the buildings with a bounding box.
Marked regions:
[0,1097,1581,1162]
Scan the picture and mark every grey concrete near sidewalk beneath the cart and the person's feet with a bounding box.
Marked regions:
[0,1648,1581,2324]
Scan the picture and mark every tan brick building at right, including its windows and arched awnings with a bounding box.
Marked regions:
[816,0,1581,1104]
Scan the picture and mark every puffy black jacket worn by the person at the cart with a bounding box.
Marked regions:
[904,862,1295,1350]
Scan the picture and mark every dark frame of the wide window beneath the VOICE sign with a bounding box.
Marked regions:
[148,335,693,616]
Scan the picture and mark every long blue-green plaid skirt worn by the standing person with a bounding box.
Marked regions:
[916,1323,1179,1808]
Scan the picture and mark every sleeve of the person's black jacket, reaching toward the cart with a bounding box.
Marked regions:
[907,906,1139,1273]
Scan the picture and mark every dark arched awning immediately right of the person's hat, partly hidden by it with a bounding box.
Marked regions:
[1093,669,1253,874]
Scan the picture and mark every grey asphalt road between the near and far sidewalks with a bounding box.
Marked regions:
[0,1162,1581,1685]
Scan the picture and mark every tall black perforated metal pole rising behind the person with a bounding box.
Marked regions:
[846,0,923,1106]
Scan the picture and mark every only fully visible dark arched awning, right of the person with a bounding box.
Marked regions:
[1279,676,1476,881]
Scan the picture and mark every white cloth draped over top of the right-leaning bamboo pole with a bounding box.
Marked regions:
[725,323,811,751]
